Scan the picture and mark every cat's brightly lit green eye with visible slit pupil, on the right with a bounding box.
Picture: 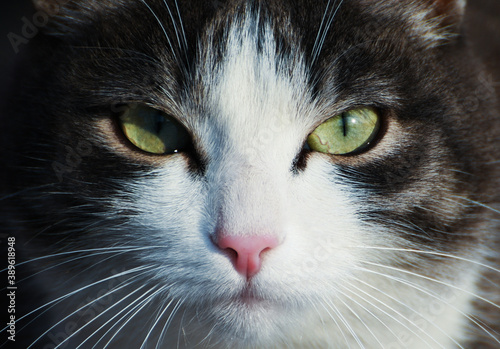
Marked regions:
[307,107,380,155]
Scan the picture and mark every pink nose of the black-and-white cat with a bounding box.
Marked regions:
[217,236,279,278]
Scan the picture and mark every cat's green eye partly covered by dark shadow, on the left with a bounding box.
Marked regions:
[119,104,191,154]
